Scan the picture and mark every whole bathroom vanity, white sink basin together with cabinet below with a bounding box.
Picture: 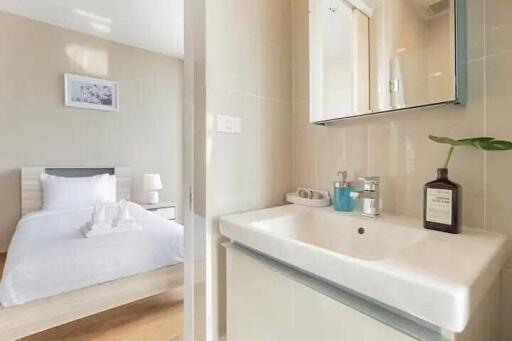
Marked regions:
[220,205,508,341]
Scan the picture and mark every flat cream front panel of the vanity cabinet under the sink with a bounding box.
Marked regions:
[227,247,415,341]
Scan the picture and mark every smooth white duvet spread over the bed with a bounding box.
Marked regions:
[0,203,183,307]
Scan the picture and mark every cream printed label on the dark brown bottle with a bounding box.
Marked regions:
[426,188,452,225]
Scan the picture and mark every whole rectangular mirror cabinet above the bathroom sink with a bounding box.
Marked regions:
[309,0,465,123]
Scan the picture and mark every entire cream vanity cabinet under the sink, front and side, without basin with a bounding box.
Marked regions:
[226,243,499,341]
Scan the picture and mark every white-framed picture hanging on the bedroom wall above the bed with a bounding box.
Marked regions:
[64,73,119,111]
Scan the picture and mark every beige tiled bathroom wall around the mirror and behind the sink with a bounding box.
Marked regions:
[292,0,512,341]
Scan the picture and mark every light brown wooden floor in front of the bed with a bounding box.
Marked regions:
[0,254,183,341]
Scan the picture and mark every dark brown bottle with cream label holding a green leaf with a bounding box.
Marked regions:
[423,168,461,233]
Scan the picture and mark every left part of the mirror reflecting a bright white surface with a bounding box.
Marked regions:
[310,0,370,121]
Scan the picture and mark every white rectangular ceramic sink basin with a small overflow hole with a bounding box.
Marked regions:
[220,205,507,332]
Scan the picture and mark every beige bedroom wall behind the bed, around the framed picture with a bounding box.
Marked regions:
[0,12,183,252]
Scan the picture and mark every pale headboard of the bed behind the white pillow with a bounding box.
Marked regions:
[21,167,132,216]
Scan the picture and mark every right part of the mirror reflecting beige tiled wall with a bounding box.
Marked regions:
[370,0,455,112]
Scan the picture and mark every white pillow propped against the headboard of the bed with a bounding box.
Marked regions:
[40,174,116,210]
